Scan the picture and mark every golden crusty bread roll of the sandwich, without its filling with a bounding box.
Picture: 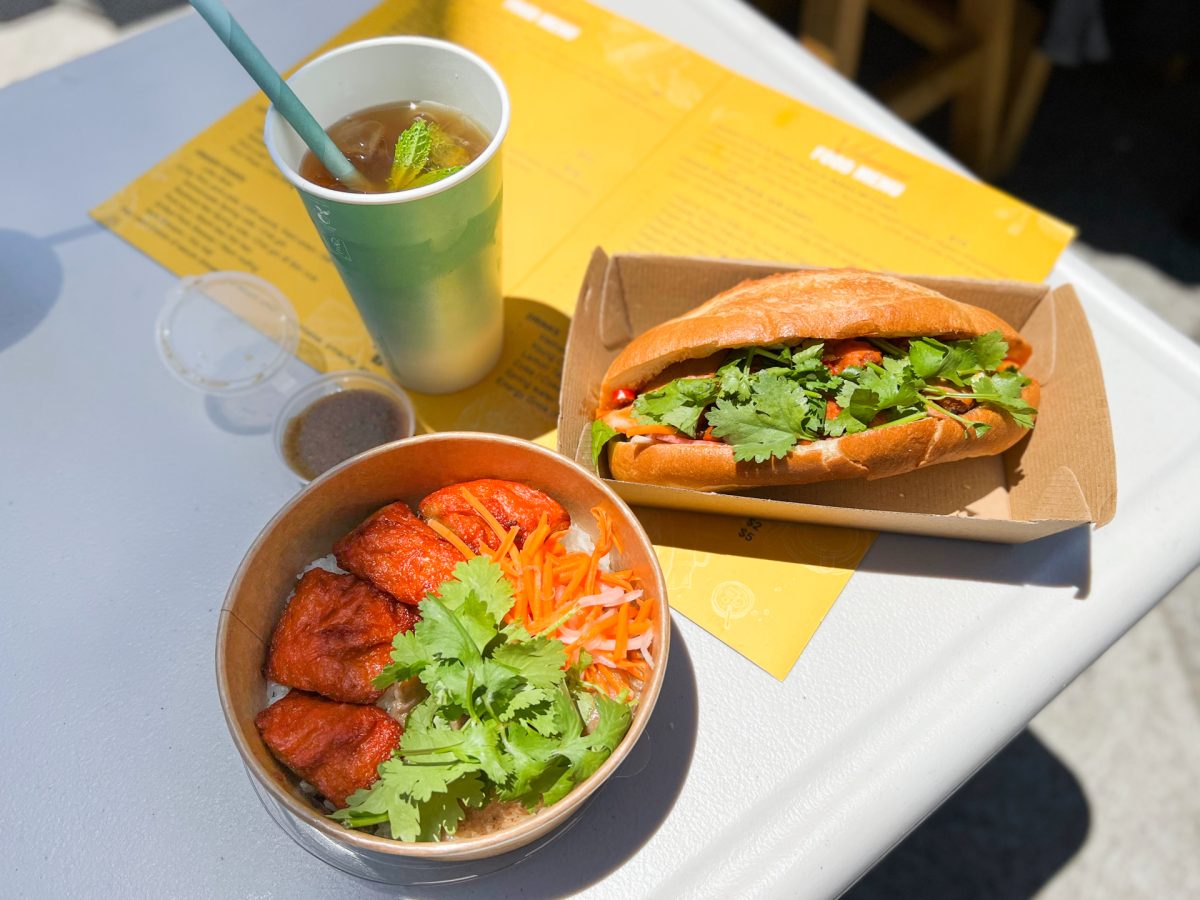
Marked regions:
[596,269,1040,491]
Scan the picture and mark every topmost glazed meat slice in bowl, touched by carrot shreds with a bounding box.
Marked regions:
[421,478,571,551]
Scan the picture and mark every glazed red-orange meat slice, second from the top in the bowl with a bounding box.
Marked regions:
[334,503,462,606]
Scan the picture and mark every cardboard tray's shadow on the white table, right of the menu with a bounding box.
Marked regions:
[858,526,1092,599]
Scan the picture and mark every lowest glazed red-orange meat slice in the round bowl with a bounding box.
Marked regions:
[254,691,404,806]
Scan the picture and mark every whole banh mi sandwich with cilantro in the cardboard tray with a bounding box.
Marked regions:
[592,269,1039,491]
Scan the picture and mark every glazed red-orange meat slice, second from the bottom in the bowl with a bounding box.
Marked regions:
[266,569,418,703]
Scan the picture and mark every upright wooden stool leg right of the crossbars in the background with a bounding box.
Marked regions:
[950,0,1014,178]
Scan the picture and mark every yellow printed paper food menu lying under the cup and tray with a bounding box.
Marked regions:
[92,0,1073,677]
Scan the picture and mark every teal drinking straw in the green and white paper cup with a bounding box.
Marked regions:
[188,0,368,191]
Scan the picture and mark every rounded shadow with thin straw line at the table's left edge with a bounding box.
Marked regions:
[0,224,87,350]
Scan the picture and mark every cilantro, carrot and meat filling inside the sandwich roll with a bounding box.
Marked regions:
[592,331,1037,463]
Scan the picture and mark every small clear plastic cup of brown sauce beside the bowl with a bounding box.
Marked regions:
[275,372,416,481]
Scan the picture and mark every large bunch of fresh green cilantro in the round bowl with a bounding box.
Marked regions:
[332,557,631,841]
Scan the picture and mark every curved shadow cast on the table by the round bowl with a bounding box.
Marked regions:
[367,629,697,900]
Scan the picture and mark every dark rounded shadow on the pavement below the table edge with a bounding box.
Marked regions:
[842,731,1091,900]
